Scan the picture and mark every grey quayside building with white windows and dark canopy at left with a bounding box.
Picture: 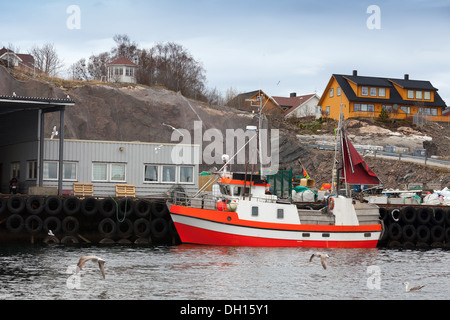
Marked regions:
[0,95,199,197]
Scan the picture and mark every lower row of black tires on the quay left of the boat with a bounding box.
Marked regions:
[6,213,176,240]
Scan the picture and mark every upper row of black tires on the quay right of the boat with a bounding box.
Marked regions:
[380,206,450,226]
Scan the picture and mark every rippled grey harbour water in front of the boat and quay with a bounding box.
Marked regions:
[0,245,450,301]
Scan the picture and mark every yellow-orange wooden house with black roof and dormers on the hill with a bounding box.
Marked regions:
[318,70,450,122]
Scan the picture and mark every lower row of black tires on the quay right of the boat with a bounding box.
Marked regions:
[382,222,450,243]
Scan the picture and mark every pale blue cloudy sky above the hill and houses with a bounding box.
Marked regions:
[0,0,450,105]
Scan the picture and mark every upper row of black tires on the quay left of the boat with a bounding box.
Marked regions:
[0,195,168,218]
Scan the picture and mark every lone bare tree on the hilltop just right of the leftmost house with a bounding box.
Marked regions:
[29,43,64,77]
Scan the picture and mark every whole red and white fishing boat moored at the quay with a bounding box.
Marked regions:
[168,100,383,248]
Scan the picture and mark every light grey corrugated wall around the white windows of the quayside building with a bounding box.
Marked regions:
[44,139,199,197]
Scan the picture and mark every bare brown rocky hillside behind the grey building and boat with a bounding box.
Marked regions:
[0,67,450,188]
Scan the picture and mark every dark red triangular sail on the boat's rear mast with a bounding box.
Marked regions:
[342,134,380,185]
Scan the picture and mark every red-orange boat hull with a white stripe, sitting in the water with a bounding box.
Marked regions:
[171,206,381,248]
